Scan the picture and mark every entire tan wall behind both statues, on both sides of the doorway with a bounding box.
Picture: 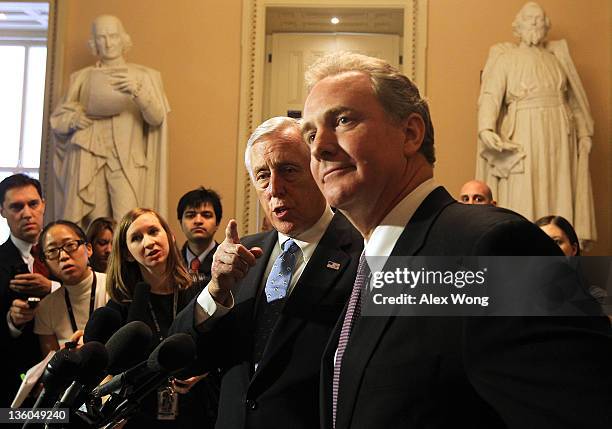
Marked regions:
[56,0,612,254]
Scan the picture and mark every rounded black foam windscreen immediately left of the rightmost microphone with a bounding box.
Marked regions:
[106,320,153,375]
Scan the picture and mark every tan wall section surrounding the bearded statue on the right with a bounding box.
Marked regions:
[427,0,612,255]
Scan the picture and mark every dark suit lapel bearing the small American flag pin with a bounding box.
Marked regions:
[251,216,351,386]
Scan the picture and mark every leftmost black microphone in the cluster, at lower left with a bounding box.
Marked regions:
[23,349,81,428]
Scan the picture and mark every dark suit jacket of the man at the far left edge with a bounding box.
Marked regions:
[0,238,42,407]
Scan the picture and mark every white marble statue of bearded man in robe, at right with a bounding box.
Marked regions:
[476,2,597,241]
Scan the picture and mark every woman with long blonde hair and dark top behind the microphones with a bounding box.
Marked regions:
[106,208,216,428]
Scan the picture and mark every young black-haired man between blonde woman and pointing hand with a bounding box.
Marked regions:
[176,186,223,283]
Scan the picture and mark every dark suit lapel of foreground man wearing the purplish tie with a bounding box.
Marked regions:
[330,187,455,429]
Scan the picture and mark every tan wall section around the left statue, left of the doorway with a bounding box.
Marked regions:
[58,0,242,243]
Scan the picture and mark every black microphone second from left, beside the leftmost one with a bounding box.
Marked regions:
[54,341,108,409]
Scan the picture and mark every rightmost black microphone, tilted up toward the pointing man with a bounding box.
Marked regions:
[95,333,196,427]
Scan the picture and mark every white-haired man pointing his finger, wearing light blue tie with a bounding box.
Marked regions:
[174,117,363,429]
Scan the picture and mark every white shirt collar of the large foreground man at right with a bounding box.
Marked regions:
[364,179,437,261]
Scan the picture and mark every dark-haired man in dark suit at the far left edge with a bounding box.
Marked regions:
[0,174,59,407]
